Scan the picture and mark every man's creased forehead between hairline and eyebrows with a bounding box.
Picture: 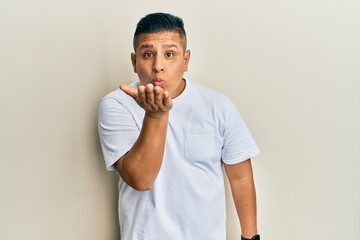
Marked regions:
[136,31,184,50]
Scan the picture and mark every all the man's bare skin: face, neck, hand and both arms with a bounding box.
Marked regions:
[116,32,257,238]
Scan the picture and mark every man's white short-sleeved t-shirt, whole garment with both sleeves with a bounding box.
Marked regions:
[99,80,259,240]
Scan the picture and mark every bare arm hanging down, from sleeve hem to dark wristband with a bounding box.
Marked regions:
[225,159,257,238]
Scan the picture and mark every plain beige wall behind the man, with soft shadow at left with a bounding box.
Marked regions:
[0,0,360,240]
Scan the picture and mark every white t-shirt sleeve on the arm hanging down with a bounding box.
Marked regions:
[222,97,260,164]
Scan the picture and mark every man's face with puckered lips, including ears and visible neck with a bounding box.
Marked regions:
[131,32,190,98]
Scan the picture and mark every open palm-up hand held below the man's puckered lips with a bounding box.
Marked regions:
[120,83,173,117]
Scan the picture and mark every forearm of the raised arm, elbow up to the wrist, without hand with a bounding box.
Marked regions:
[116,112,168,190]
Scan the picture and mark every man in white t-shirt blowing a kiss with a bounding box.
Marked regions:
[99,13,259,240]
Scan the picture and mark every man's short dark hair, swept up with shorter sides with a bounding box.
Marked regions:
[133,12,186,51]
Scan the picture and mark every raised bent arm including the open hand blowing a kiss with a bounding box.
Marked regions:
[116,84,172,190]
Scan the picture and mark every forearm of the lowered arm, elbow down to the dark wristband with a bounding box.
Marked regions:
[231,176,257,238]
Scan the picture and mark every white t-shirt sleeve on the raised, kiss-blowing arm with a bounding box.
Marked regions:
[98,95,139,171]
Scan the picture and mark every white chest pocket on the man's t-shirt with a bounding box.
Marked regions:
[184,128,221,161]
